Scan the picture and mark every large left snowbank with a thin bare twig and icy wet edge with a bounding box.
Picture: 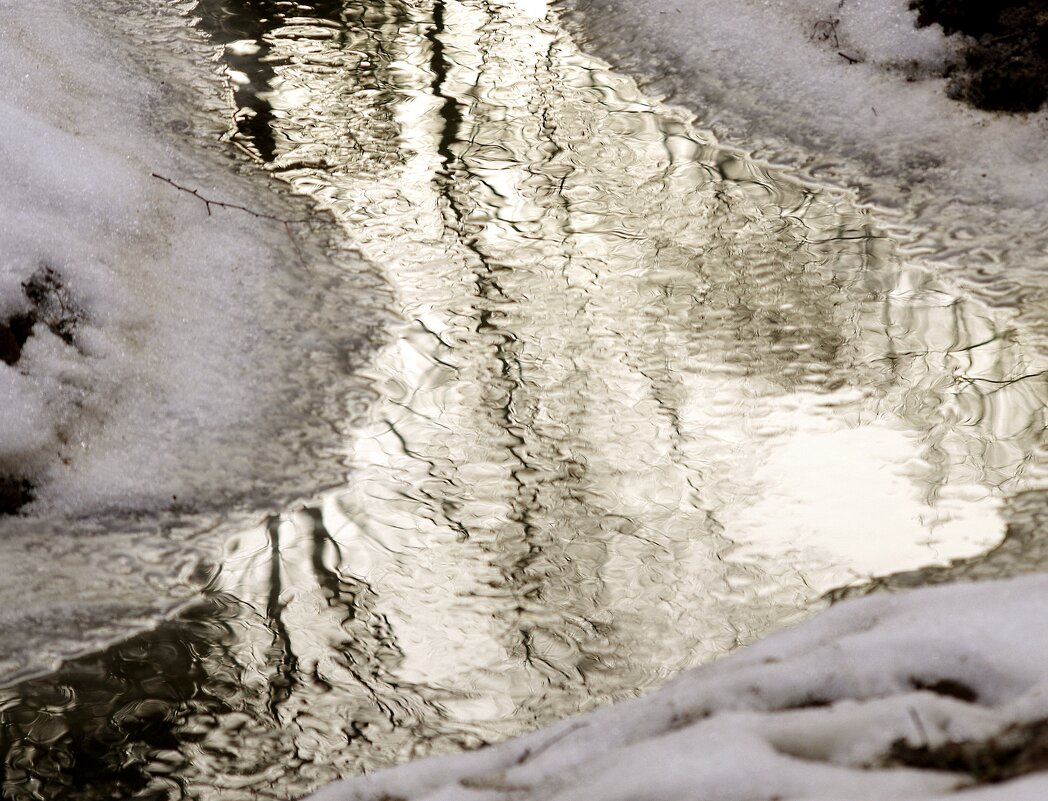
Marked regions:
[0,0,384,676]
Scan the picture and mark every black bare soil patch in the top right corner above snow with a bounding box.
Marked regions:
[910,0,1048,113]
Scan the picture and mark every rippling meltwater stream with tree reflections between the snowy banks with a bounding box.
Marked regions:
[0,0,1046,801]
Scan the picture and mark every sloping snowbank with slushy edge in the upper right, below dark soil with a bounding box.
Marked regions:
[562,0,1048,335]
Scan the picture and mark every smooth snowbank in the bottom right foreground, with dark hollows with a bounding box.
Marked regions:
[312,576,1048,801]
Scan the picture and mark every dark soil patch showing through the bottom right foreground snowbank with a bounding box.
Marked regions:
[889,720,1048,783]
